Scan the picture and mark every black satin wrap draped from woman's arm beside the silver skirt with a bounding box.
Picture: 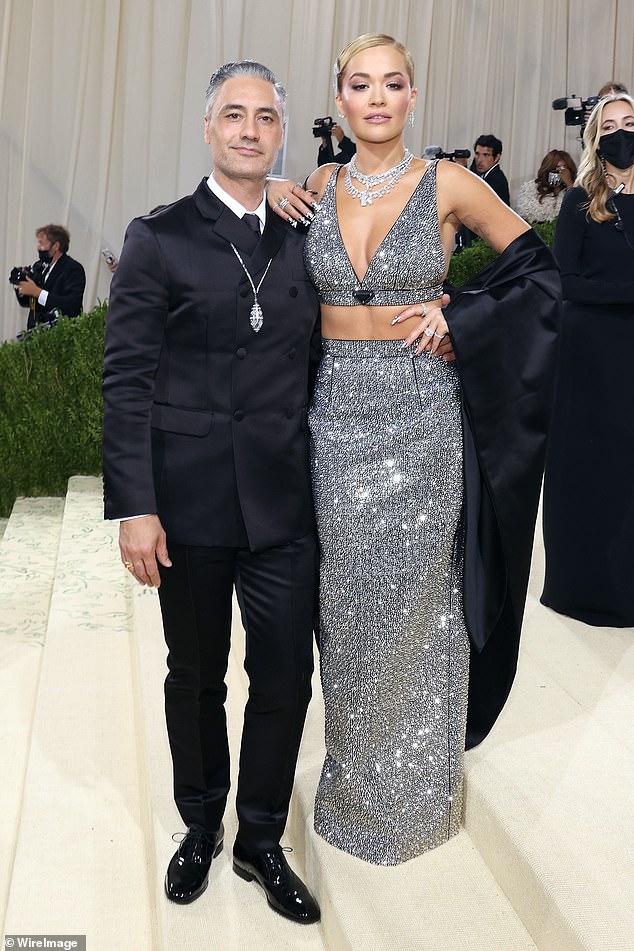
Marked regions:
[445,230,561,749]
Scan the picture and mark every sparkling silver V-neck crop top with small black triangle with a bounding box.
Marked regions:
[304,162,447,307]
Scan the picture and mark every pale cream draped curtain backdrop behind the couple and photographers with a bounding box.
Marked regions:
[0,0,634,340]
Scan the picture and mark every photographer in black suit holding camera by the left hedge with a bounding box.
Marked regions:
[15,225,86,330]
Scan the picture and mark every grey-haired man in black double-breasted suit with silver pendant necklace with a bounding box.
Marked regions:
[103,62,320,923]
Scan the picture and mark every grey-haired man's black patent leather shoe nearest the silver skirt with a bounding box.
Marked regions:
[233,842,321,925]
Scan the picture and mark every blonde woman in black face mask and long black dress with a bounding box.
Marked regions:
[542,92,634,627]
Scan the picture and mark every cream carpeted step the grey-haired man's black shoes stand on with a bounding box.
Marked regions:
[130,580,331,951]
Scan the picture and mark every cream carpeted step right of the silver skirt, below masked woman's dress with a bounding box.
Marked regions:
[466,539,634,951]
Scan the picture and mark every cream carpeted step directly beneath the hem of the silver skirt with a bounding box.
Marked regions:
[290,693,537,951]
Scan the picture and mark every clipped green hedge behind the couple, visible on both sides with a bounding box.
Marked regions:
[0,224,554,517]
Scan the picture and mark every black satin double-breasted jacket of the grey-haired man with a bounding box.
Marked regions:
[103,179,320,551]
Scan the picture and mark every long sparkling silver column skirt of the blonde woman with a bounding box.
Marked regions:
[309,340,469,865]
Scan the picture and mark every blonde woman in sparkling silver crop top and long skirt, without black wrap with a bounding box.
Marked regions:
[269,35,556,865]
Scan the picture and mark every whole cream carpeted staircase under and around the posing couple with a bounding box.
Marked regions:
[0,477,634,951]
